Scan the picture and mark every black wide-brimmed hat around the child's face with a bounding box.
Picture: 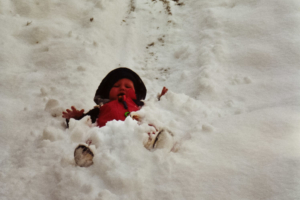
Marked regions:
[94,67,147,104]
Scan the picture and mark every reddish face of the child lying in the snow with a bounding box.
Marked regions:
[109,78,135,101]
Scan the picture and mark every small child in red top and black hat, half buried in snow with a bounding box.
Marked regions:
[63,68,168,167]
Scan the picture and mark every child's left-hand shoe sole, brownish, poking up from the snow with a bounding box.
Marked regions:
[74,144,94,167]
